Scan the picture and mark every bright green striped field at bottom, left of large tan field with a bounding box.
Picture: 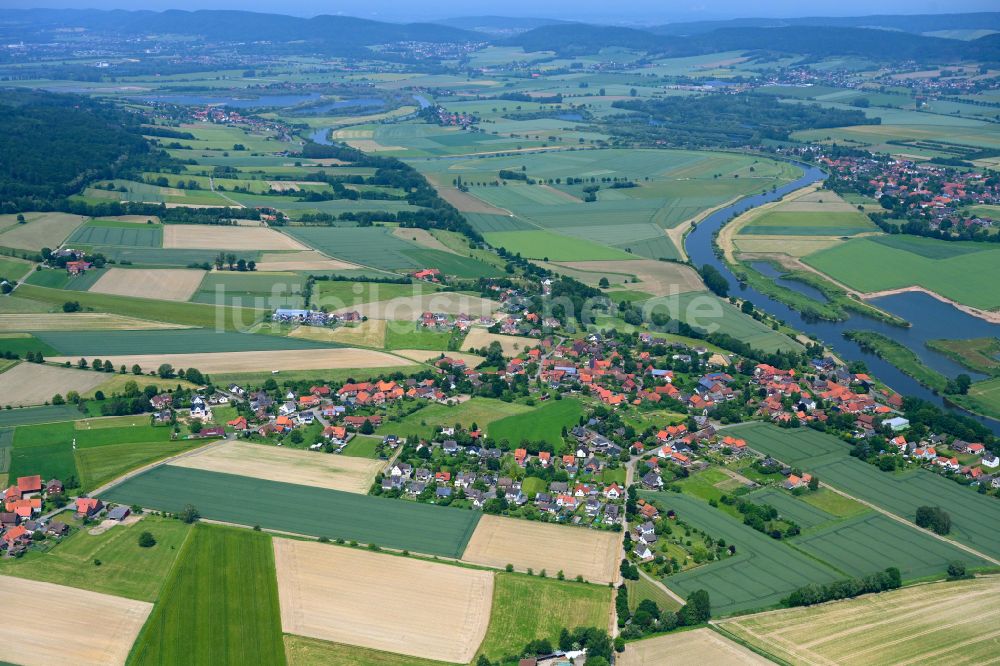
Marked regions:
[129,525,285,666]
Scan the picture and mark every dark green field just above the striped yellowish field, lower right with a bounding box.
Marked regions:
[792,512,989,580]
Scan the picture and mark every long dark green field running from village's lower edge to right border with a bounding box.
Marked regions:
[732,424,1000,557]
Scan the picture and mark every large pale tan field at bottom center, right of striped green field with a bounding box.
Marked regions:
[274,539,493,664]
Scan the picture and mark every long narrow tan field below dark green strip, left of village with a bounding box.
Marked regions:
[50,348,412,373]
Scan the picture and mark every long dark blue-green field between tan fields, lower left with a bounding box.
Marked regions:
[104,465,480,557]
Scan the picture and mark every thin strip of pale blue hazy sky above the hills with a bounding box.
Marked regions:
[7,0,1000,23]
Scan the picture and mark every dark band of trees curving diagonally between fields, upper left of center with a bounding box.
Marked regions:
[302,141,483,243]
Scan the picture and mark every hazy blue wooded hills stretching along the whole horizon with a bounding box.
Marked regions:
[0,9,1000,62]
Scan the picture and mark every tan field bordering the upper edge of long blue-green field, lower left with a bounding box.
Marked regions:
[169,442,383,494]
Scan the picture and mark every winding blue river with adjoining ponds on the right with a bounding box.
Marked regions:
[684,165,1000,434]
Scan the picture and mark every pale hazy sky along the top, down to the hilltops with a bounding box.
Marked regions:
[6,0,996,25]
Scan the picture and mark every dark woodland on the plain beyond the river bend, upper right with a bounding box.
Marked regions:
[608,93,880,147]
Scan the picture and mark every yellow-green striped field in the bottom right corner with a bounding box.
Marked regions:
[720,576,1000,666]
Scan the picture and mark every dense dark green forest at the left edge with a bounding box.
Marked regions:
[0,91,171,213]
